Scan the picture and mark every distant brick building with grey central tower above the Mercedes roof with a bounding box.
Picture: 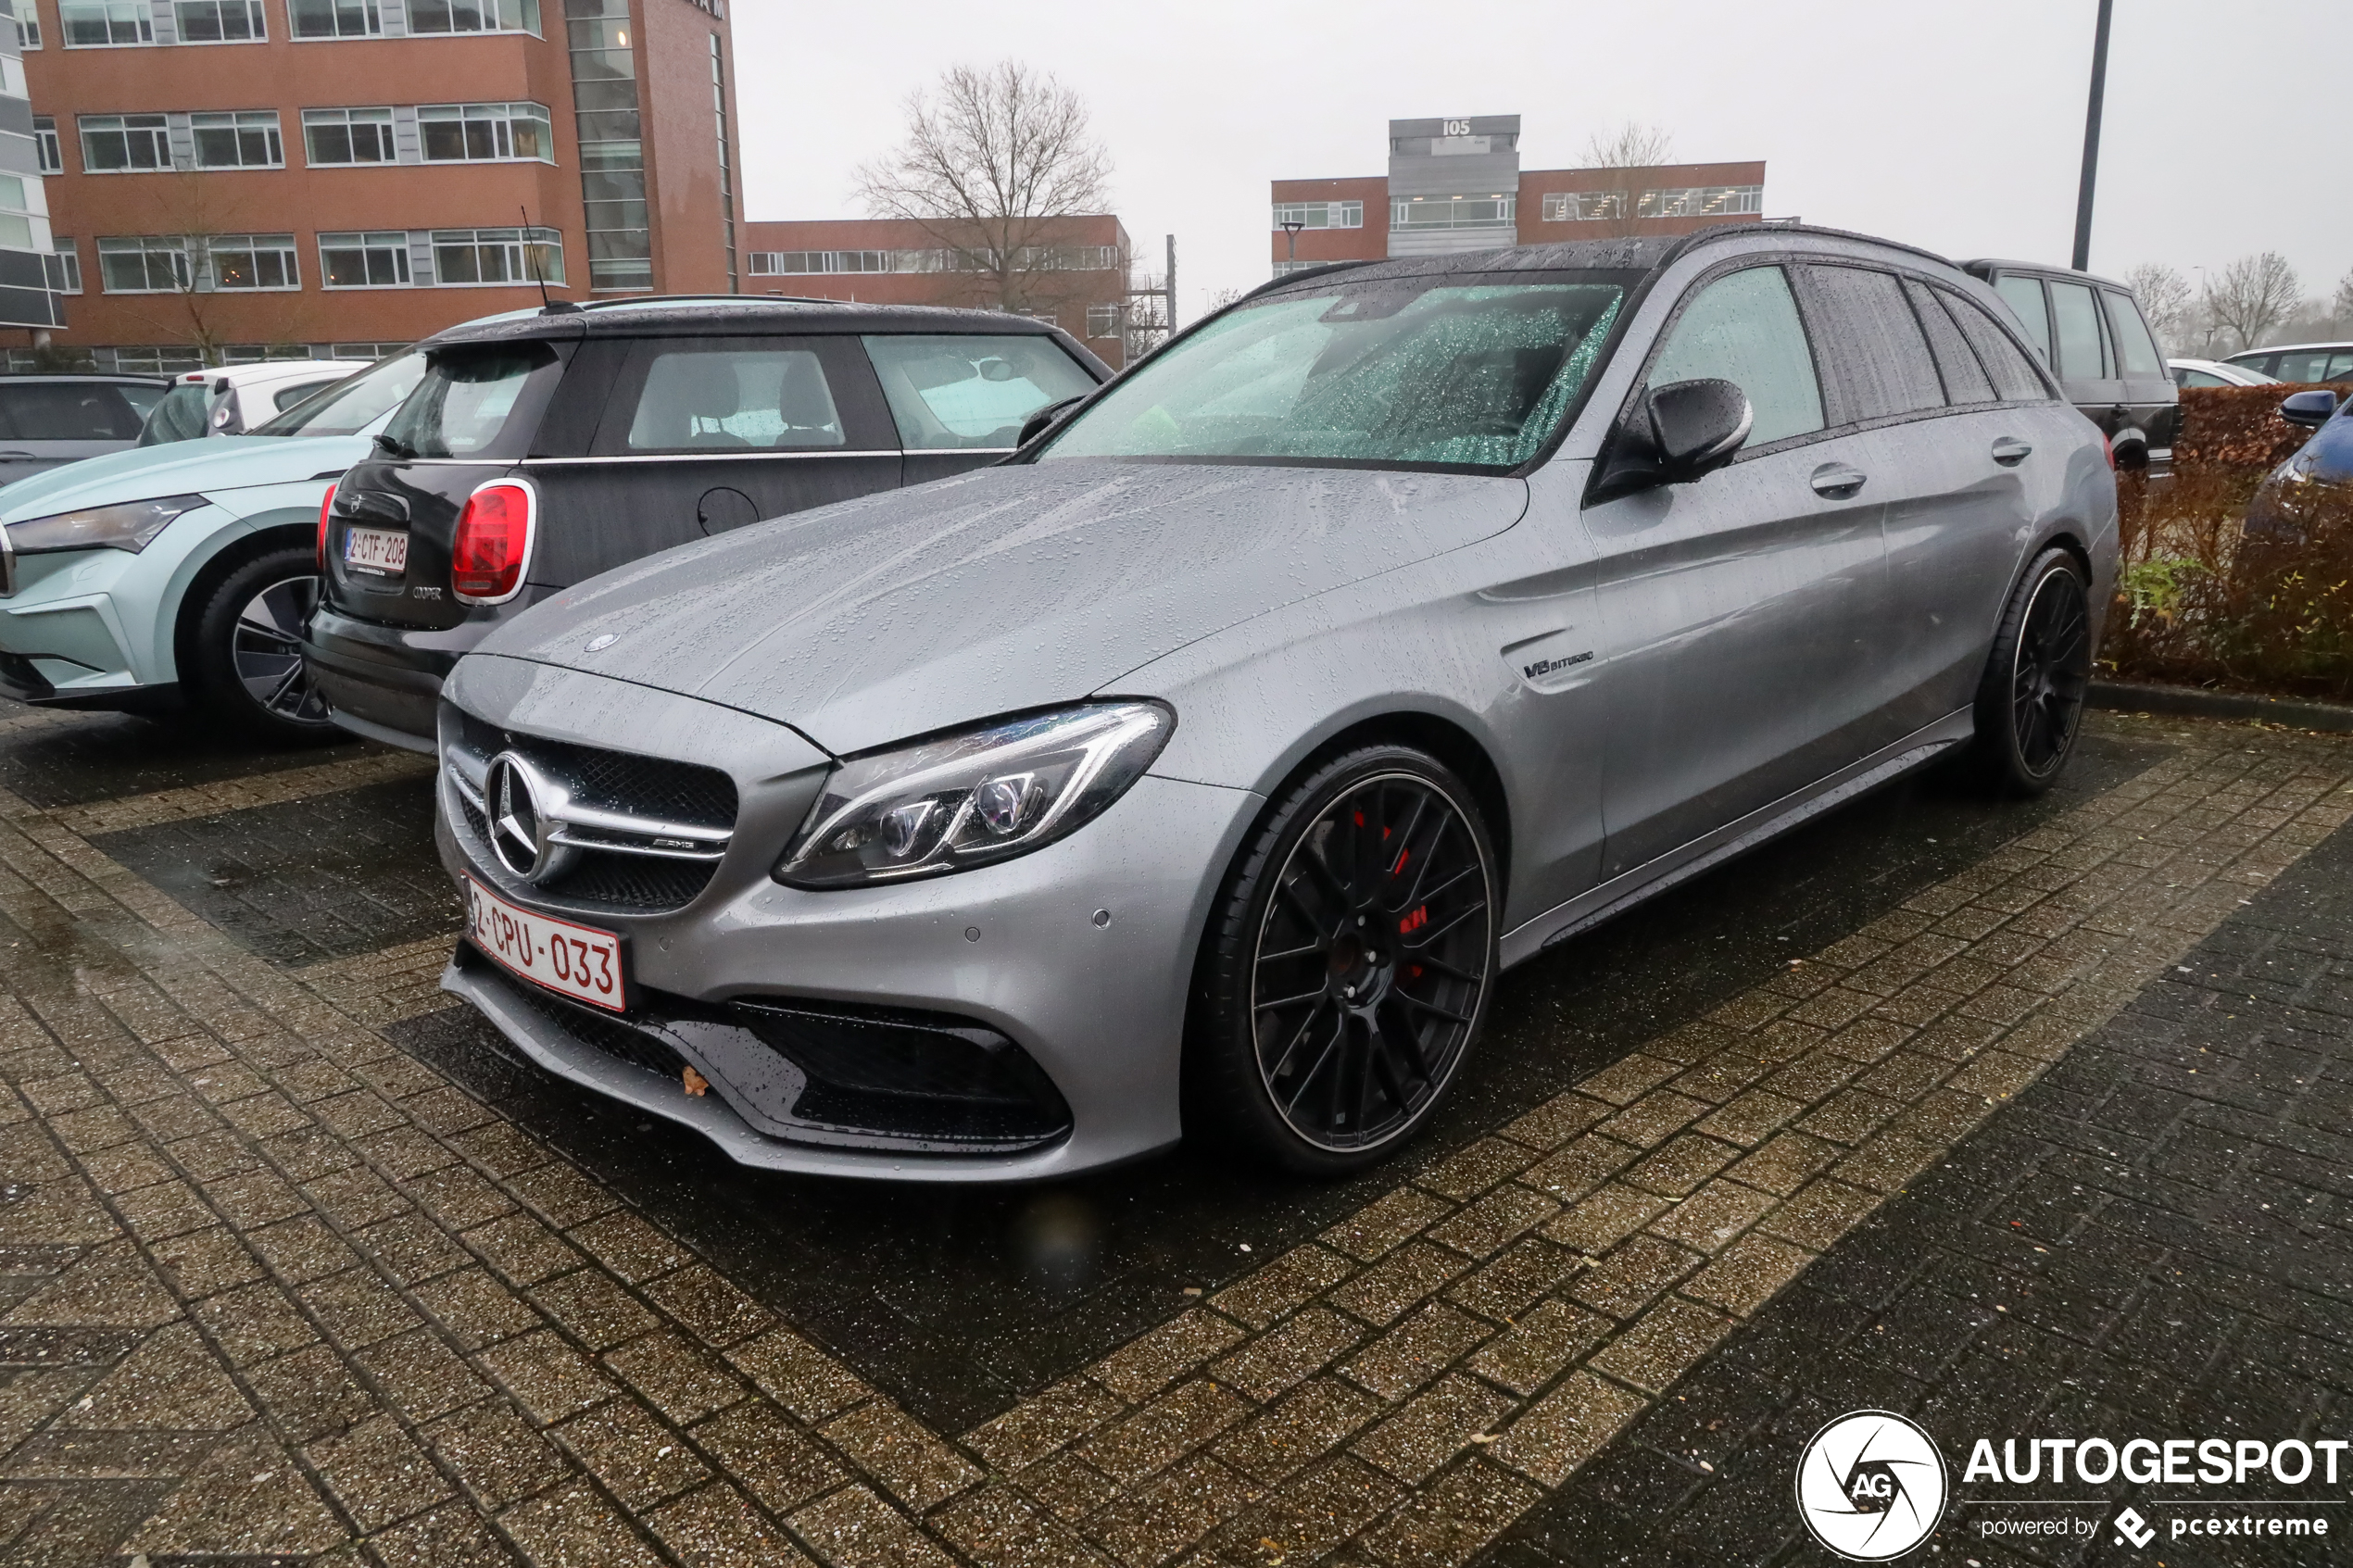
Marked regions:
[1271,115,1765,278]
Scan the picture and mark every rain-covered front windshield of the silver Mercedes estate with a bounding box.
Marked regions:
[1040,275,1626,470]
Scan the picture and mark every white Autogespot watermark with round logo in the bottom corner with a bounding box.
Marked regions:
[1798,1411,2353,1563]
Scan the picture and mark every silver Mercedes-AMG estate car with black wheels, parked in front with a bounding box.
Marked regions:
[437,226,2115,1180]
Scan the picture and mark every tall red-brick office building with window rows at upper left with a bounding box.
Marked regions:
[17,0,741,370]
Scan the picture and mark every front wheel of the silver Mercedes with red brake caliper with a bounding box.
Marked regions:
[1186,746,1502,1175]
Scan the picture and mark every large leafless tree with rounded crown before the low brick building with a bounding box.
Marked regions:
[857,61,1127,315]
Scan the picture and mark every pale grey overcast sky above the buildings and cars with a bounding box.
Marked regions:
[734,0,2353,320]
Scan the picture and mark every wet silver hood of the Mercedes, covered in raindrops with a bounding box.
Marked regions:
[480,460,1527,755]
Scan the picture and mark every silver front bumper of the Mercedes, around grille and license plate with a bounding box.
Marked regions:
[435,660,1261,1183]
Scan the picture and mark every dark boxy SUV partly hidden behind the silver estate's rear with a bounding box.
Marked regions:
[1960,261,2182,470]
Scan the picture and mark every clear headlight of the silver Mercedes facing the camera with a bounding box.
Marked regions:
[776,703,1176,888]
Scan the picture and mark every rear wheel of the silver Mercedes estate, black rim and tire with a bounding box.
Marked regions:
[1974,550,2092,797]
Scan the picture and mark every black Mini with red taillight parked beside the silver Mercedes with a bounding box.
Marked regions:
[304,298,1111,752]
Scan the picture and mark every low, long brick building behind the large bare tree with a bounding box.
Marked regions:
[744,214,1129,364]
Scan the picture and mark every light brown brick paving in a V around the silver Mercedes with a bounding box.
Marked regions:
[0,726,2353,1568]
